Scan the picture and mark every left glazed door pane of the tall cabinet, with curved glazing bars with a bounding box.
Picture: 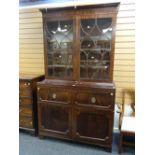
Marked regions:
[46,20,73,78]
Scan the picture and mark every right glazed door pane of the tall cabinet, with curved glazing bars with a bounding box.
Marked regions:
[80,18,112,80]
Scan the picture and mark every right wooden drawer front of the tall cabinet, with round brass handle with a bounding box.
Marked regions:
[75,91,115,108]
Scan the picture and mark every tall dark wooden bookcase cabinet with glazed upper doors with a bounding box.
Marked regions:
[37,3,118,150]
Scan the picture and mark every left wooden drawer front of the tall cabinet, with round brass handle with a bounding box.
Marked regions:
[38,87,71,103]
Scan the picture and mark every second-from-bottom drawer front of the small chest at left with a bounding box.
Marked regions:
[19,106,32,117]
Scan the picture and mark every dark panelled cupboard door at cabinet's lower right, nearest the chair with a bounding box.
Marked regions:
[73,107,113,146]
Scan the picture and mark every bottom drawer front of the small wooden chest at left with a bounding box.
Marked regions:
[19,117,33,128]
